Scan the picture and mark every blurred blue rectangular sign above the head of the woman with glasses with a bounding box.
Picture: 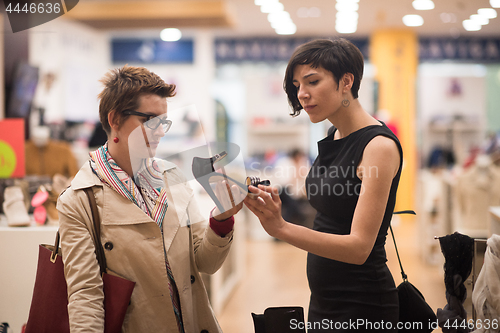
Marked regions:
[111,39,193,64]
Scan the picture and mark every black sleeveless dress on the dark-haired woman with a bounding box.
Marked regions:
[306,123,403,332]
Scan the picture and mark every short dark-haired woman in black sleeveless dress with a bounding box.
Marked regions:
[245,39,403,332]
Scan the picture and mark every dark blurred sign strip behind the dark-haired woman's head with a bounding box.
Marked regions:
[215,38,368,63]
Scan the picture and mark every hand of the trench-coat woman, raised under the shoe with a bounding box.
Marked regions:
[212,181,246,221]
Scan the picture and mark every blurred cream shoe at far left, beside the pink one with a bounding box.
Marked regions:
[3,186,30,227]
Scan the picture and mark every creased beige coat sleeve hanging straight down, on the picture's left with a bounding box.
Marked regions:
[57,188,104,333]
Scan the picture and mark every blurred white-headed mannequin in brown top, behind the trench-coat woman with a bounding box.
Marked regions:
[26,126,78,178]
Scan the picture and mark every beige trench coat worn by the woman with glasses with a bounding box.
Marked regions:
[57,163,233,333]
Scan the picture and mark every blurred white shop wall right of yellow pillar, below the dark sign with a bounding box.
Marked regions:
[417,63,487,164]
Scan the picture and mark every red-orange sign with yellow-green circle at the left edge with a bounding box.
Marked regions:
[0,118,25,178]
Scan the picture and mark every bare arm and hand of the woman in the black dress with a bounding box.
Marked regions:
[245,136,400,265]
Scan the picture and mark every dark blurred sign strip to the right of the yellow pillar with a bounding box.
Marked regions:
[419,38,500,63]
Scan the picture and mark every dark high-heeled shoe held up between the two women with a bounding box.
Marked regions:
[192,151,270,212]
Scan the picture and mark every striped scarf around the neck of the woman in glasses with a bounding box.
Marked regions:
[90,143,184,333]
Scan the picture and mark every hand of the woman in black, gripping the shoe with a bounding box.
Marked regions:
[244,185,288,239]
